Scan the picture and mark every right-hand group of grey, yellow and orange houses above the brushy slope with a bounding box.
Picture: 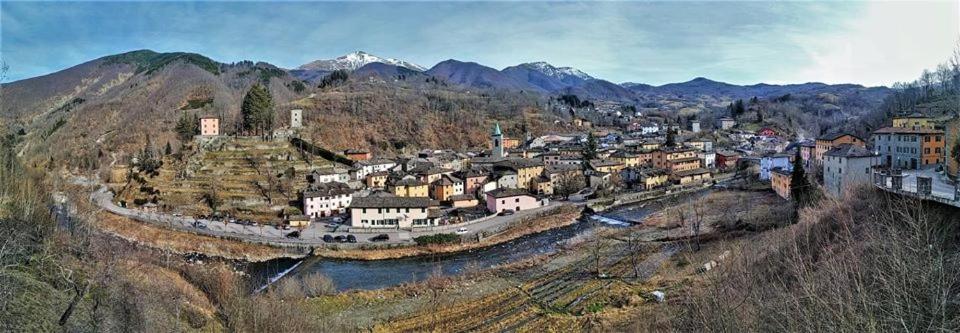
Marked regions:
[761,113,948,198]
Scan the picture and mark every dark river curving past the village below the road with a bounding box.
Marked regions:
[246,192,703,291]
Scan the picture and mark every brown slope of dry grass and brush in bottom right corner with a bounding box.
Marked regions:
[674,189,960,332]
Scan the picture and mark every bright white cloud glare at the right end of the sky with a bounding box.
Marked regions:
[782,1,960,85]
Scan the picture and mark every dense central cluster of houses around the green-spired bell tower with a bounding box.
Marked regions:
[296,118,739,228]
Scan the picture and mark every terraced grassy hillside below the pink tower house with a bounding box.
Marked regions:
[120,138,344,222]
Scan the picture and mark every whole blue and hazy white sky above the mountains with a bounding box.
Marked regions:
[0,0,960,86]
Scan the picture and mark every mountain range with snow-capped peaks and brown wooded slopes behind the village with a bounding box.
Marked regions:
[0,50,889,161]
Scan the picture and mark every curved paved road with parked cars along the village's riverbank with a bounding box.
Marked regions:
[90,186,561,246]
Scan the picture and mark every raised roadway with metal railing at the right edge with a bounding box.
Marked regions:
[873,168,960,207]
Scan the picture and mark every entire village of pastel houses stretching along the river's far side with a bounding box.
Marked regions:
[103,105,960,246]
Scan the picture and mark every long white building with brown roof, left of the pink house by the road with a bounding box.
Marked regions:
[350,197,439,229]
